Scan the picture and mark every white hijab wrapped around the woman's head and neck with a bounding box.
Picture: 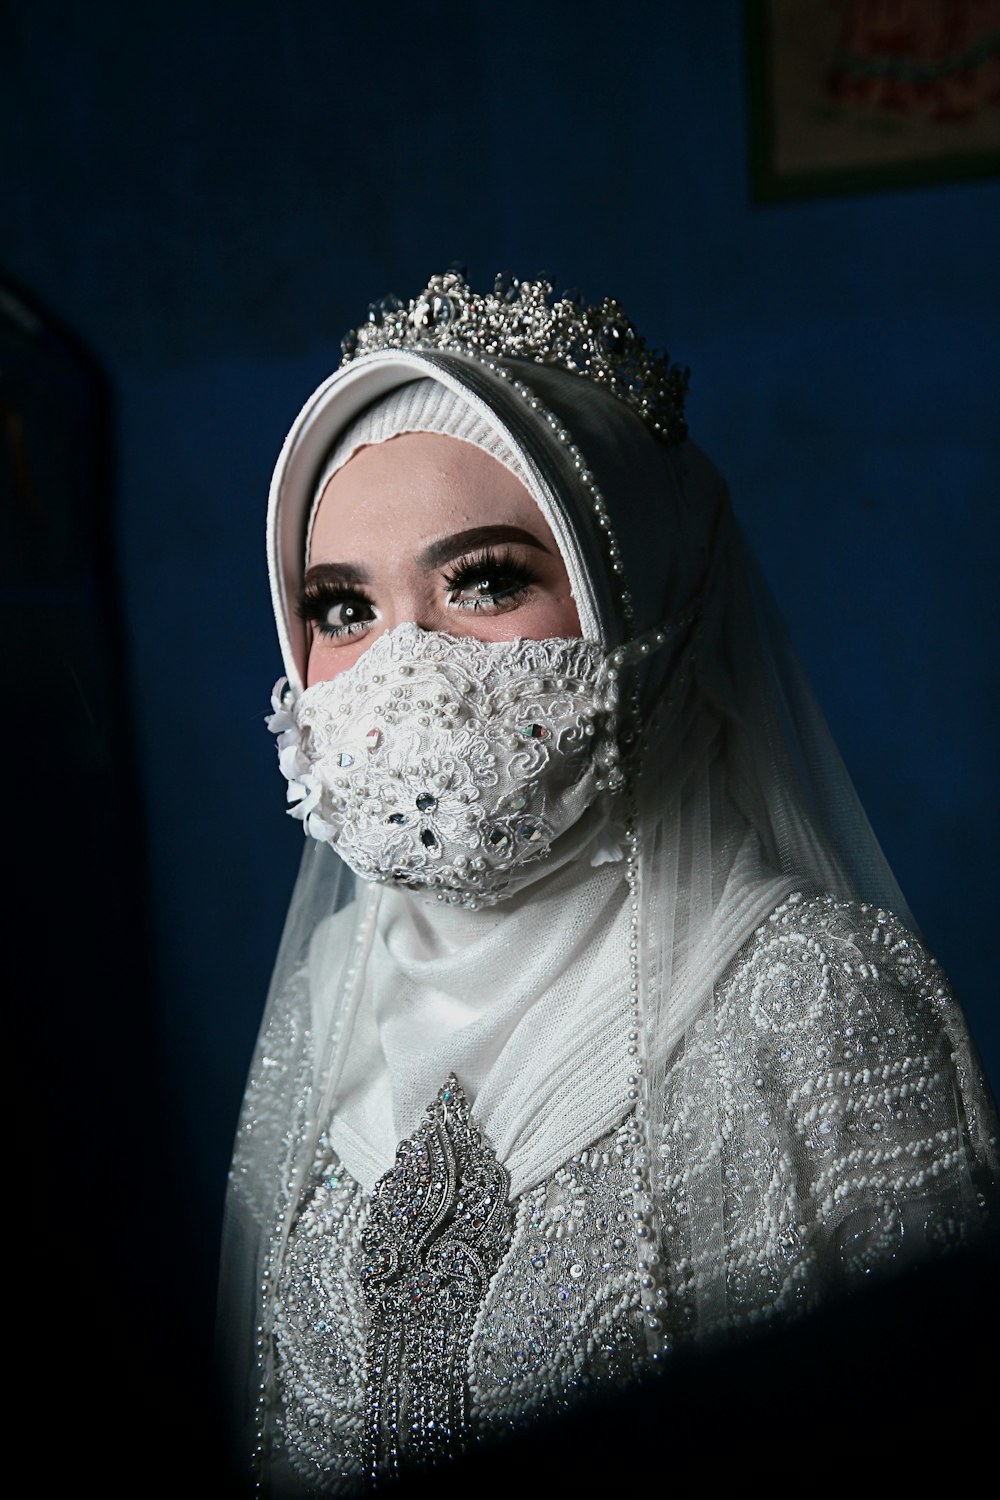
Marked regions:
[256,354,901,1197]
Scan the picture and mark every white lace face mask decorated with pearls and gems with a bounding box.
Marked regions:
[267,624,622,906]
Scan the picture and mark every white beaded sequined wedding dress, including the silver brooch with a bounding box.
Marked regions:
[238,897,997,1494]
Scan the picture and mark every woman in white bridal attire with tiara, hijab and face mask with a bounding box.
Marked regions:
[225,273,996,1494]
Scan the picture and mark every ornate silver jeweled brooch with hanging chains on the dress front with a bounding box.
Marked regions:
[360,1077,513,1479]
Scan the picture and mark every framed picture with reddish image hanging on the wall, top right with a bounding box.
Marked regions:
[745,0,1000,203]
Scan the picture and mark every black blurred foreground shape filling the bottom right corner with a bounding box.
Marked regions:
[399,1233,1000,1497]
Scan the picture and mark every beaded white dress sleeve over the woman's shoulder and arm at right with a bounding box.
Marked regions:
[654,896,997,1337]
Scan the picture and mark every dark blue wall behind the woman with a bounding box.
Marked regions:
[0,0,1000,1338]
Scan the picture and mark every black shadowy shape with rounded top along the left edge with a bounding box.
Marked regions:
[0,281,230,1493]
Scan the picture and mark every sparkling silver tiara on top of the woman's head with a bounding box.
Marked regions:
[342,269,690,443]
